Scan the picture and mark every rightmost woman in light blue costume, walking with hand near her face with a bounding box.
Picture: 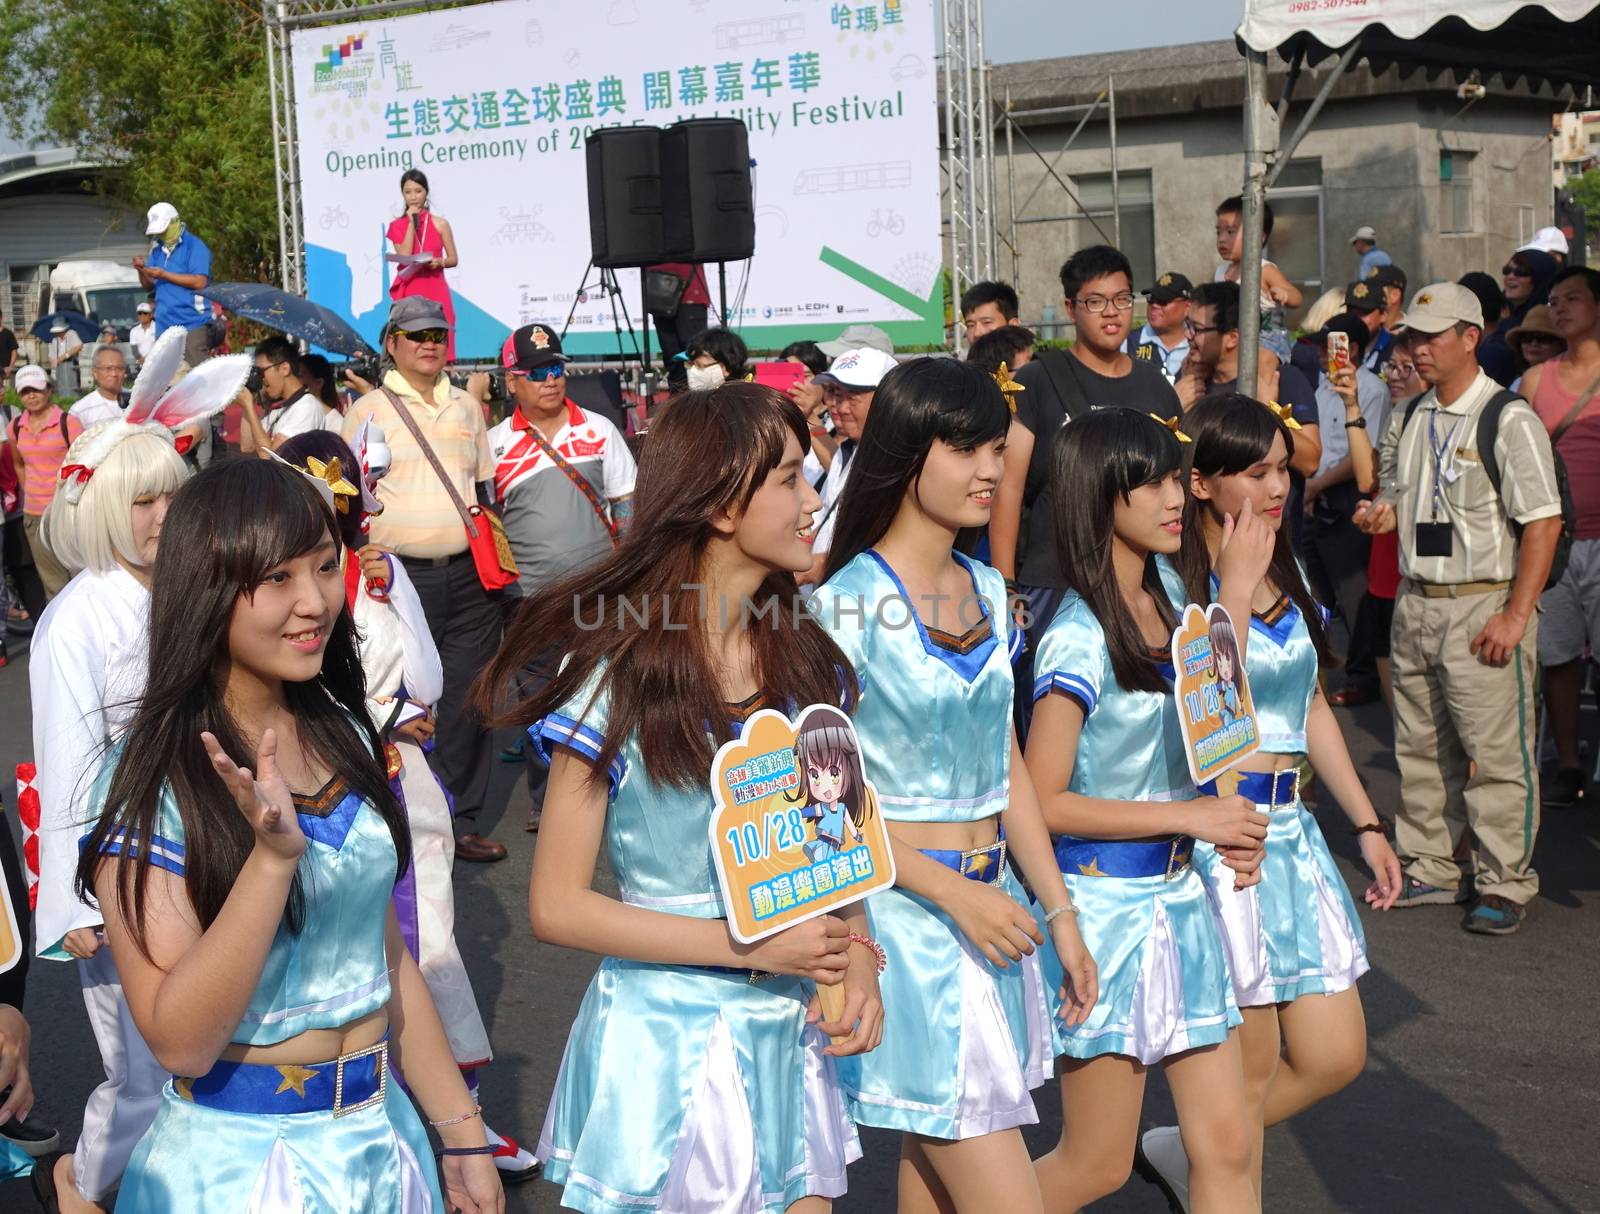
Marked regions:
[1141,395,1400,1209]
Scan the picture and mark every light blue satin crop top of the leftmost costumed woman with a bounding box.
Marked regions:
[90,744,397,1046]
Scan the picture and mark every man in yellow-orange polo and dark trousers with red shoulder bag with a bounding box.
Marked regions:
[342,296,506,862]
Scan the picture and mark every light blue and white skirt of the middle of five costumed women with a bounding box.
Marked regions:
[838,845,1056,1140]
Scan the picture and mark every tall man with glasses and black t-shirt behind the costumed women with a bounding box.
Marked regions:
[989,245,1178,728]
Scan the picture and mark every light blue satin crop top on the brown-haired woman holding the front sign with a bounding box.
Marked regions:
[528,673,784,920]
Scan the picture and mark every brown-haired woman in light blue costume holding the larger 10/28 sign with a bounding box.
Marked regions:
[478,382,898,1214]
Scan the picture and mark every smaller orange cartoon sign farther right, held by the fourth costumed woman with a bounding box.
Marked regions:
[1173,603,1261,784]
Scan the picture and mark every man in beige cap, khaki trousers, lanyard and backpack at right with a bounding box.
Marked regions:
[1355,283,1562,936]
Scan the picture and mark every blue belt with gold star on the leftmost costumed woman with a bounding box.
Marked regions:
[173,1040,389,1116]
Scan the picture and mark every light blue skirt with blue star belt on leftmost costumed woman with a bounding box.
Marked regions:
[117,1052,445,1214]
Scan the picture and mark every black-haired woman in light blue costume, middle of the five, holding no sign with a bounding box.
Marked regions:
[813,358,1096,1214]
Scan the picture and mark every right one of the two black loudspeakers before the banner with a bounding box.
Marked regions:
[665,118,755,261]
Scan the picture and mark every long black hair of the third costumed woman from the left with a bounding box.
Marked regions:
[822,358,1011,581]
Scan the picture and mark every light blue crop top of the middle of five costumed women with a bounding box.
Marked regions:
[811,550,1021,822]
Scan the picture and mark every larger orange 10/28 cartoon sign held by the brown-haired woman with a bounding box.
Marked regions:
[710,704,894,944]
